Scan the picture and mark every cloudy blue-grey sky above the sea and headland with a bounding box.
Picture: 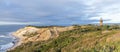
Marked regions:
[0,0,120,25]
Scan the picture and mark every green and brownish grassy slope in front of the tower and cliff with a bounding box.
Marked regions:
[8,26,120,52]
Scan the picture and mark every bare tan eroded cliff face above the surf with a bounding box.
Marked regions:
[13,26,74,43]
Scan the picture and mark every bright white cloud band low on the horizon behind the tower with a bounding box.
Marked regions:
[90,13,120,23]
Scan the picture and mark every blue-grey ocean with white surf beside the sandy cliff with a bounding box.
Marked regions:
[0,25,24,52]
